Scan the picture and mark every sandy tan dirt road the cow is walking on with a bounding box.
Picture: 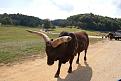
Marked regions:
[0,40,121,81]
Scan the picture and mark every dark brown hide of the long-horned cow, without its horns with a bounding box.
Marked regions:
[46,32,89,77]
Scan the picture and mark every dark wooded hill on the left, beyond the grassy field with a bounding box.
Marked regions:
[0,13,43,27]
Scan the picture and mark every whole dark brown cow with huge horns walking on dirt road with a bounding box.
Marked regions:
[27,30,89,78]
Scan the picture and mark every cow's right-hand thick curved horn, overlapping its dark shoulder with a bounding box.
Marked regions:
[51,36,72,48]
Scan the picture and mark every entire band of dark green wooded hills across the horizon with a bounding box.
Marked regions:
[0,13,121,31]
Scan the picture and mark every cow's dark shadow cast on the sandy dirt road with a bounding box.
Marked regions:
[57,62,92,81]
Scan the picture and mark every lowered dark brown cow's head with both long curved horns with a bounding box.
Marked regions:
[27,30,72,65]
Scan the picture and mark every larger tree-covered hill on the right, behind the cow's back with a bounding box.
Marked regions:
[53,13,121,31]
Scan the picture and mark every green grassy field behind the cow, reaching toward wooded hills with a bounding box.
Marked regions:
[0,26,101,64]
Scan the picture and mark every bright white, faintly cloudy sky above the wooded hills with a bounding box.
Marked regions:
[0,0,121,20]
